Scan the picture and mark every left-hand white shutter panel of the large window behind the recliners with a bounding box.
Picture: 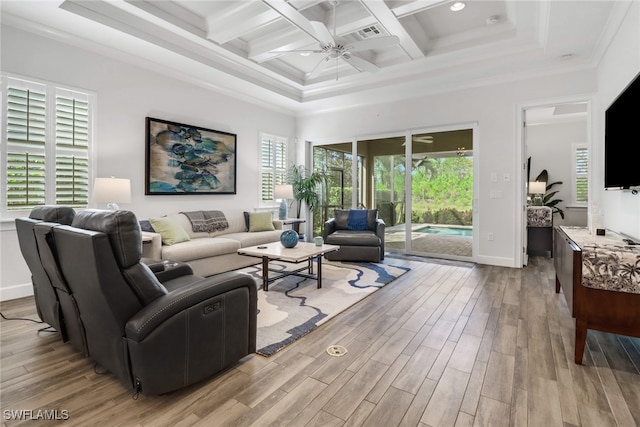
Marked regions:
[6,86,46,209]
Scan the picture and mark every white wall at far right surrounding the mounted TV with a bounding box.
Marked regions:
[592,2,640,239]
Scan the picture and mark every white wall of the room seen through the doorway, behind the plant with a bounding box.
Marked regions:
[527,119,588,227]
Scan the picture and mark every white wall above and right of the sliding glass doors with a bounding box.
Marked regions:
[298,70,596,267]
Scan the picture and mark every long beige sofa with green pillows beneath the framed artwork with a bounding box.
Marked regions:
[142,210,282,276]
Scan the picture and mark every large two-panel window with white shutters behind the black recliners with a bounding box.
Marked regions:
[1,76,92,213]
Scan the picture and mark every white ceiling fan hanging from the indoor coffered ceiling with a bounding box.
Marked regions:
[273,0,400,80]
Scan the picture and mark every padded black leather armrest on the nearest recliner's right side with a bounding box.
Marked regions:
[125,272,257,342]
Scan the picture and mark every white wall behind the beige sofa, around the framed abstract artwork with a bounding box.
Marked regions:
[0,27,295,299]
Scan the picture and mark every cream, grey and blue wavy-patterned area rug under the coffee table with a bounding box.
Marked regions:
[241,261,409,356]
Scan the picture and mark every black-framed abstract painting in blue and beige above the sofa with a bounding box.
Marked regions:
[145,117,237,195]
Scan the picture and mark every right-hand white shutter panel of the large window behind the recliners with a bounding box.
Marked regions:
[55,96,89,207]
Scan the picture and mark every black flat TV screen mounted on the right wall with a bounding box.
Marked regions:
[604,70,640,189]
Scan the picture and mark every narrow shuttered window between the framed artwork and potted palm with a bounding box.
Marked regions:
[260,134,288,205]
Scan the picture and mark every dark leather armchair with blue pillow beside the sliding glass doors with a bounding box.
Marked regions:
[322,209,385,262]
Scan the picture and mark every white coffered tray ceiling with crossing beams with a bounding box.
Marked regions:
[1,0,629,112]
